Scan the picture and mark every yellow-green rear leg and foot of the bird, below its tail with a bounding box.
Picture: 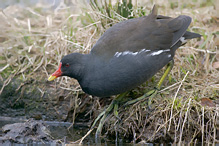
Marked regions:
[124,60,174,106]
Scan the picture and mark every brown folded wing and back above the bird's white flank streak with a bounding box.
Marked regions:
[91,6,191,59]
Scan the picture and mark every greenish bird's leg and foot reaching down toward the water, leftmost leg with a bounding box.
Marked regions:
[91,92,128,138]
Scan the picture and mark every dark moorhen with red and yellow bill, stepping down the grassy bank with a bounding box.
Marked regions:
[48,6,201,135]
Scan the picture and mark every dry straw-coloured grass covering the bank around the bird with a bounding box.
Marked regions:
[0,0,219,143]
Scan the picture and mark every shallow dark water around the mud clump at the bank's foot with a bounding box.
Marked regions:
[0,117,136,146]
